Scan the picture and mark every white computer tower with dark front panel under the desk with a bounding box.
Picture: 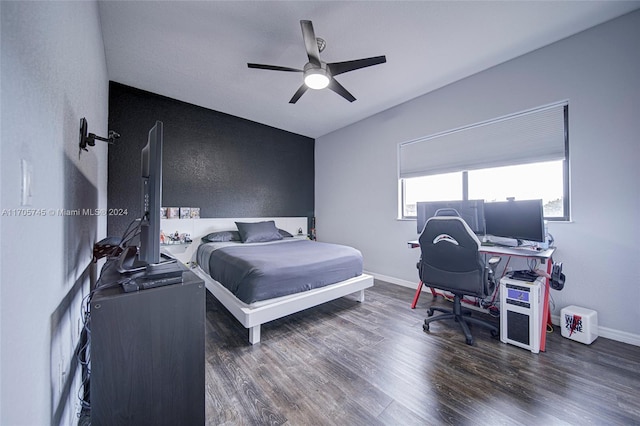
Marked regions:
[500,276,545,353]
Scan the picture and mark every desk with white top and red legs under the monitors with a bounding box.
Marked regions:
[407,240,556,352]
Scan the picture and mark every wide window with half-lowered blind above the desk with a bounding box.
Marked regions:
[398,103,569,220]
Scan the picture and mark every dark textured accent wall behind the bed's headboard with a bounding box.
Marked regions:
[109,82,315,236]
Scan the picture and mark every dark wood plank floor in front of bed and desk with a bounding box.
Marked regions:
[206,281,640,426]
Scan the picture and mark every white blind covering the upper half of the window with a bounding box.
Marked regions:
[398,102,567,179]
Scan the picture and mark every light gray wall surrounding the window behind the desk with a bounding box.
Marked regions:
[316,11,640,345]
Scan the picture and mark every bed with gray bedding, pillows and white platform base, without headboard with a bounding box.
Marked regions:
[194,221,373,344]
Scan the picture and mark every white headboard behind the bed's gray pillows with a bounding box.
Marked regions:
[160,216,308,263]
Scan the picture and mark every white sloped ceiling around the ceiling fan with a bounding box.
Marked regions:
[100,1,640,138]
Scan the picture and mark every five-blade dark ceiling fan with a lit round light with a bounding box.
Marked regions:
[247,20,387,104]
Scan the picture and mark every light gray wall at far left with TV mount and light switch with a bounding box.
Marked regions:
[0,1,108,425]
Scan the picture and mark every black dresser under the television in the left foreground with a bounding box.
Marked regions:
[90,267,205,426]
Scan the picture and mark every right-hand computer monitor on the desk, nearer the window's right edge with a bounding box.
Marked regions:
[484,200,545,245]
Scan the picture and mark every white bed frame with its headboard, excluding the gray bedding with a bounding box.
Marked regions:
[170,217,373,345]
